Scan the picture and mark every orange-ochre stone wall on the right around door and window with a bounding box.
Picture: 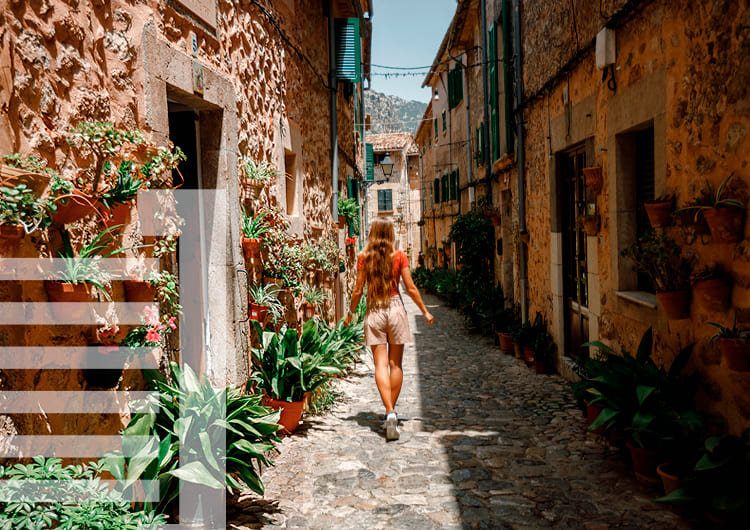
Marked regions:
[522,0,750,432]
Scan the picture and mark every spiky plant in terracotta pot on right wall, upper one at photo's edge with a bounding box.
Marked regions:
[678,173,745,243]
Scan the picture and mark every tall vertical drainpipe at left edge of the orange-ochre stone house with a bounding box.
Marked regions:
[513,0,529,321]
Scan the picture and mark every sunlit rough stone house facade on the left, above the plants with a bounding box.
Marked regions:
[0,0,372,434]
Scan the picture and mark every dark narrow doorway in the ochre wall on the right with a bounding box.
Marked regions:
[558,145,590,358]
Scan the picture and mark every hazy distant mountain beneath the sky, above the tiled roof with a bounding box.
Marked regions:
[365,90,427,134]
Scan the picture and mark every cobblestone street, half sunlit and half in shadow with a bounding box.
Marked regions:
[228,296,689,529]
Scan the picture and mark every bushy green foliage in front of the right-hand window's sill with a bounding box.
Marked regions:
[622,231,694,293]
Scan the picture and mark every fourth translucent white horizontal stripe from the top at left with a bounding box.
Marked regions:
[0,390,157,414]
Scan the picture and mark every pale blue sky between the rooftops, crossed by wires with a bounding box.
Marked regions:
[371,0,456,103]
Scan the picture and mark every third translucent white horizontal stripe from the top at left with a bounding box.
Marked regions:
[0,346,158,370]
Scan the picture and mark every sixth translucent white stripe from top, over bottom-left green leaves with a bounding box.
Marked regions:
[0,479,159,504]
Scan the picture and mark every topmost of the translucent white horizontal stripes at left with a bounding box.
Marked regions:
[0,258,159,281]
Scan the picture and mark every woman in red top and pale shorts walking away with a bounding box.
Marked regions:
[344,218,435,440]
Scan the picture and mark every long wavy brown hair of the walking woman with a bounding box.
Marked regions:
[364,217,395,308]
